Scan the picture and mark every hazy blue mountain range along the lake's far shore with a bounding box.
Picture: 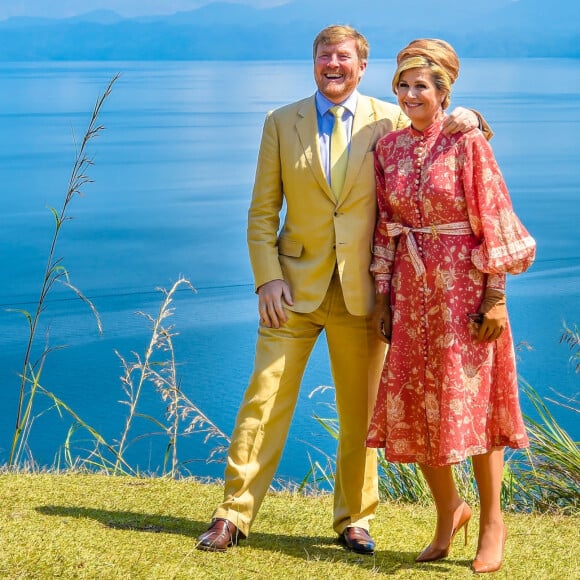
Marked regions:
[0,0,580,61]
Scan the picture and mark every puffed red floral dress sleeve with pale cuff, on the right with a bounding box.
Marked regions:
[463,132,536,274]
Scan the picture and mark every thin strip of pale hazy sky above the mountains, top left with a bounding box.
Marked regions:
[0,0,288,20]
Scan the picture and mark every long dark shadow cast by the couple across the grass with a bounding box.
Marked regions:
[35,505,470,577]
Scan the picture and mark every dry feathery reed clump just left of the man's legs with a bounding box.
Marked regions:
[26,277,230,478]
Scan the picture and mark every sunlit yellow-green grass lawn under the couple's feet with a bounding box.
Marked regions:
[0,473,580,580]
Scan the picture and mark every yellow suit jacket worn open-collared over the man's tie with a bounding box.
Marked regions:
[248,95,409,315]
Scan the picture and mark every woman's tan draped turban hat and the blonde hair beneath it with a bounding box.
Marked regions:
[392,38,459,109]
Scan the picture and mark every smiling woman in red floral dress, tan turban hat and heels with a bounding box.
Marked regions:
[367,39,535,572]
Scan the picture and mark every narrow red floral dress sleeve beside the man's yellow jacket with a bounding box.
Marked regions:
[371,144,395,294]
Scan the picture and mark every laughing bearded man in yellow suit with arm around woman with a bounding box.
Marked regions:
[197,26,478,554]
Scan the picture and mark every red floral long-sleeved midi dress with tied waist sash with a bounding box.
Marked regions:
[367,120,536,466]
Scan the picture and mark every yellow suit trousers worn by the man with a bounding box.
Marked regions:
[213,273,385,536]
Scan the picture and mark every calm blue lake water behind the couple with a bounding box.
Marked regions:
[0,59,580,479]
